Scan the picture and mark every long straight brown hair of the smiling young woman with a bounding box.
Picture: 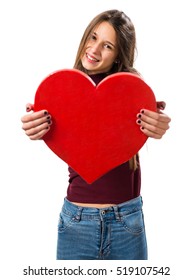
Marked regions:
[74,10,139,170]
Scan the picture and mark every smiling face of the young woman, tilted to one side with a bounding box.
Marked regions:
[81,21,118,75]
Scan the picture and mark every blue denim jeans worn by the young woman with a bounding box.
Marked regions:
[57,196,147,260]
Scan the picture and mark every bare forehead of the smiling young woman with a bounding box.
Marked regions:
[92,21,117,43]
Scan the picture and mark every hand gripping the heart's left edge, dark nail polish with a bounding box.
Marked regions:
[21,103,52,140]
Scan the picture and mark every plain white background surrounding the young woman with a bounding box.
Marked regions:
[0,0,193,279]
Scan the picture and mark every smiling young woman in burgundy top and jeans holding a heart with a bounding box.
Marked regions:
[21,10,170,260]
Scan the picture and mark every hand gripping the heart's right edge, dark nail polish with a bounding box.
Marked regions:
[136,102,171,139]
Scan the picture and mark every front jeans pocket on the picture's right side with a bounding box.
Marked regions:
[121,210,145,235]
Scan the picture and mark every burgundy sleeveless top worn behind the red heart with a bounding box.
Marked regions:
[67,74,141,204]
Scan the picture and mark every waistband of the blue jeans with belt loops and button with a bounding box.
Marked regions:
[62,196,143,221]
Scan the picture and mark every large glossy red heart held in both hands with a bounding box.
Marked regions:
[34,70,156,183]
